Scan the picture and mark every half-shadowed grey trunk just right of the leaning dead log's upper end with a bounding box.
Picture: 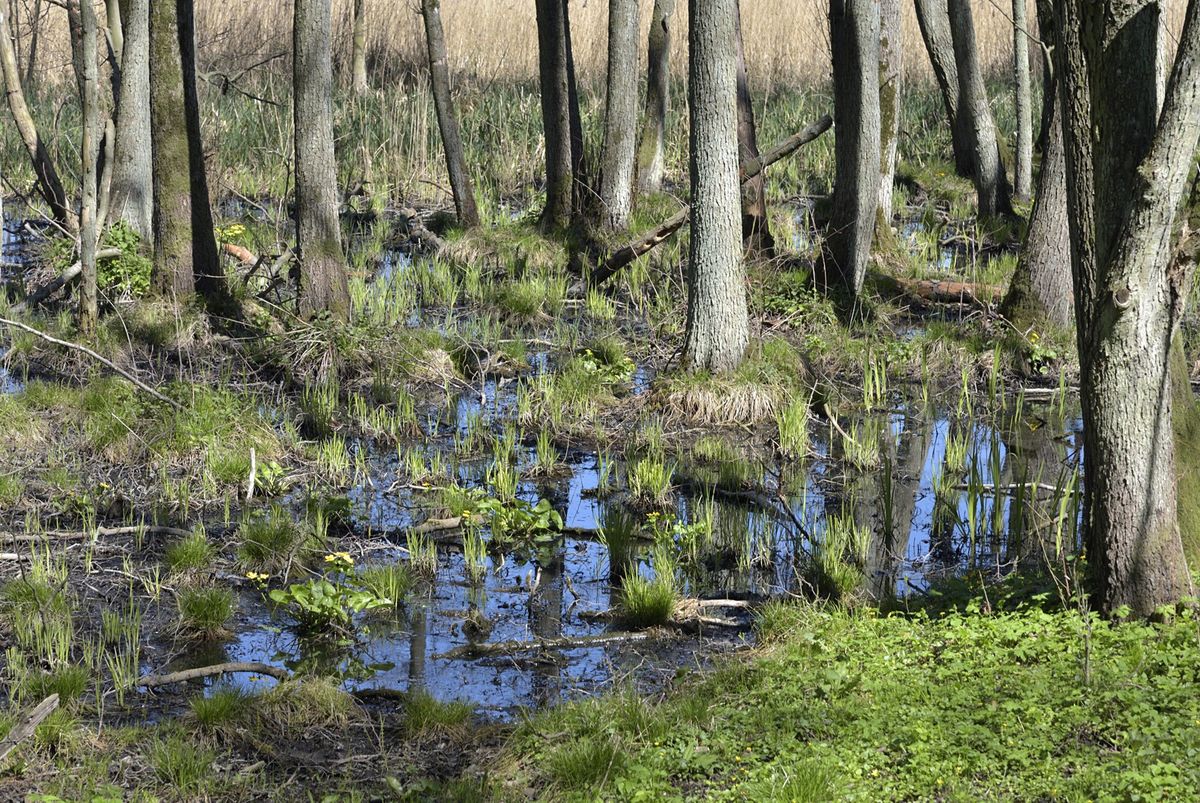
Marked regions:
[826,0,880,301]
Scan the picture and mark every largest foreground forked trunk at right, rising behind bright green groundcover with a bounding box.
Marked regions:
[1055,0,1200,615]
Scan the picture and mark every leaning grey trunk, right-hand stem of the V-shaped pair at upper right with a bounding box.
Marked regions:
[949,0,1013,217]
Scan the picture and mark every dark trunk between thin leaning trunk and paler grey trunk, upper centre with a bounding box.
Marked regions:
[536,0,574,229]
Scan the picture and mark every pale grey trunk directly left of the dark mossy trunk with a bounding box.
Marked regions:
[108,0,154,244]
